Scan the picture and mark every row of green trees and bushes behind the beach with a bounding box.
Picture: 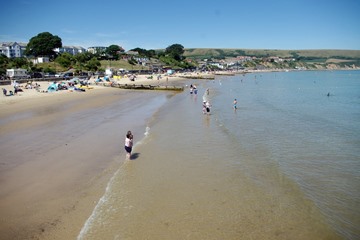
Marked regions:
[0,32,193,75]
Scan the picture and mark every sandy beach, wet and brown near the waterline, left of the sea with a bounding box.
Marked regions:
[0,73,191,239]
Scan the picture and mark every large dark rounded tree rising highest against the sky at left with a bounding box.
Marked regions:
[25,32,62,58]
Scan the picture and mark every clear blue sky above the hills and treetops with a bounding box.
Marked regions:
[0,0,360,50]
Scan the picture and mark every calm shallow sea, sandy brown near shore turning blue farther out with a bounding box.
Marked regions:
[77,70,360,240]
